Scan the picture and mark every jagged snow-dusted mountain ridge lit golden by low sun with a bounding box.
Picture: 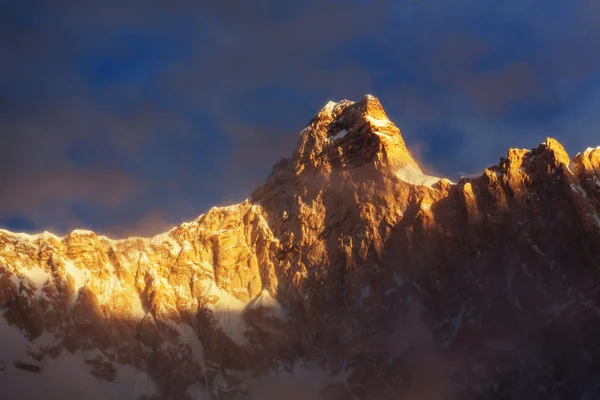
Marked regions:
[0,96,600,399]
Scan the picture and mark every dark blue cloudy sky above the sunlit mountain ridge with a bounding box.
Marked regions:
[0,0,600,237]
